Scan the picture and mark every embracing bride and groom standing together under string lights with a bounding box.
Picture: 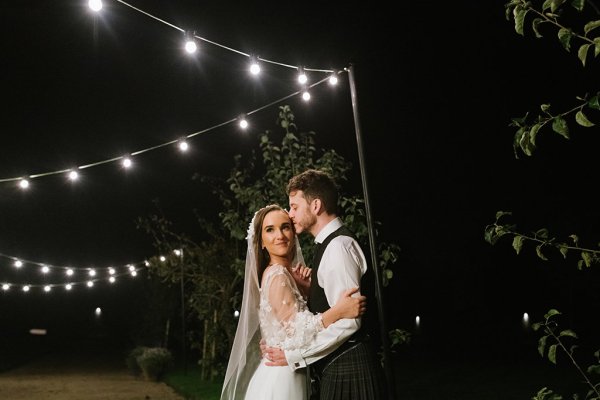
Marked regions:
[221,170,386,400]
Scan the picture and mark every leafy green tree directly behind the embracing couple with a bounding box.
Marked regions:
[140,106,409,378]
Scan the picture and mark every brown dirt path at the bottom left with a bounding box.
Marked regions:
[0,342,184,400]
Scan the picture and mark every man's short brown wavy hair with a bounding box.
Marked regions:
[286,169,339,215]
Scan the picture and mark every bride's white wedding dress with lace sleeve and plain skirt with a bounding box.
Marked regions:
[245,265,323,400]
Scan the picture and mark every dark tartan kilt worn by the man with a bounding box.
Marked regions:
[319,342,387,400]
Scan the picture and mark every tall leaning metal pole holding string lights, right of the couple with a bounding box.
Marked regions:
[348,65,396,400]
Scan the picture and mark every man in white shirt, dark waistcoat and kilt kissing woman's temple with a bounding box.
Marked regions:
[263,169,386,400]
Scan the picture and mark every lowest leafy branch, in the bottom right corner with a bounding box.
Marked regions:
[532,309,600,400]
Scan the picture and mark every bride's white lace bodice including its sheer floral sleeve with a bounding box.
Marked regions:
[258,264,323,350]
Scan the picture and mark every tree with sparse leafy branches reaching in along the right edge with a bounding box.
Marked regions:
[485,0,600,400]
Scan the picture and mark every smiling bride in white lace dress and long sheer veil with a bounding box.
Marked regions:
[221,204,365,400]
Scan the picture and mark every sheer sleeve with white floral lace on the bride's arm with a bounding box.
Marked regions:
[265,267,324,349]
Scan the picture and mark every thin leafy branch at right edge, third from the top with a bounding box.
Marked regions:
[485,211,600,270]
